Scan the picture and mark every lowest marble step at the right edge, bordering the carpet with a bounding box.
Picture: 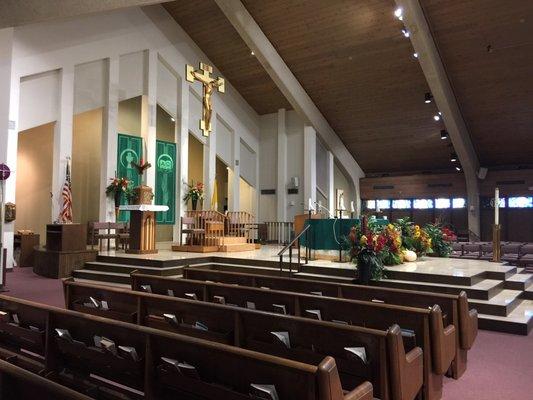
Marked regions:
[478,300,533,335]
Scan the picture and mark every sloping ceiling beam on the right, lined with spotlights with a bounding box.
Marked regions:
[391,0,480,236]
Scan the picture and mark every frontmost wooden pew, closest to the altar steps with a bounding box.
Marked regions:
[183,267,478,379]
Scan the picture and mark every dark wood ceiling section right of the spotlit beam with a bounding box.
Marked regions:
[421,0,533,166]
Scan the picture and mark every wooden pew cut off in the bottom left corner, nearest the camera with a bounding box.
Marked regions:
[0,360,91,400]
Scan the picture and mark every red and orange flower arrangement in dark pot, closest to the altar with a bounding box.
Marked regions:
[348,218,387,284]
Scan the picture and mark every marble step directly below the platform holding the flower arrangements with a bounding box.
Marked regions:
[376,278,504,300]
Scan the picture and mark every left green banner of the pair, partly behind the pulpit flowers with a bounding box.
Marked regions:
[117,133,142,222]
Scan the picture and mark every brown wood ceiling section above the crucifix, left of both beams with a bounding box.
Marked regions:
[163,0,292,114]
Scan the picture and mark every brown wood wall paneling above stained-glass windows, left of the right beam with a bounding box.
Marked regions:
[360,173,466,199]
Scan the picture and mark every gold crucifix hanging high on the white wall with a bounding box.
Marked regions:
[185,63,225,136]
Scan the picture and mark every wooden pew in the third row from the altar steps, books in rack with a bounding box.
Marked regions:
[63,279,422,399]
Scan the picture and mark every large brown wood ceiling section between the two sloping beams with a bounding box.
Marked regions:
[243,0,451,172]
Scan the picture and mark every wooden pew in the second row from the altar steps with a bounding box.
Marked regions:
[127,273,450,398]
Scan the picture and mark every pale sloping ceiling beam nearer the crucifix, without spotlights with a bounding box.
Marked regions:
[215,0,364,188]
